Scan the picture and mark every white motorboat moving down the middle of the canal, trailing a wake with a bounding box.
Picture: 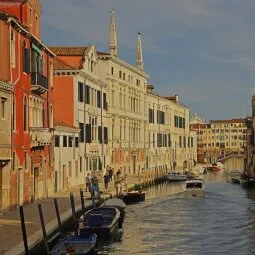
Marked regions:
[184,179,205,197]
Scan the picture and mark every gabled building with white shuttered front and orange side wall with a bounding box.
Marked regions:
[51,45,109,187]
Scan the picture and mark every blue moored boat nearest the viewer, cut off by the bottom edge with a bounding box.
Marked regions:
[50,234,97,255]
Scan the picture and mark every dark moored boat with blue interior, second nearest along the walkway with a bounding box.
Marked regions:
[79,207,120,239]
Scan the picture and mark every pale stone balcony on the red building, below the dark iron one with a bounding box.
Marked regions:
[30,127,52,147]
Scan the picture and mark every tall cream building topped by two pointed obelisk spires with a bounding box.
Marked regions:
[98,11,149,174]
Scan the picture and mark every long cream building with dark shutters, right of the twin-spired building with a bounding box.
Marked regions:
[146,88,197,170]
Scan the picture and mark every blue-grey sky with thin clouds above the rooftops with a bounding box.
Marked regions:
[40,0,255,120]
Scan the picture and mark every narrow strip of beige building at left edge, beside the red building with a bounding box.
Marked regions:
[0,80,13,212]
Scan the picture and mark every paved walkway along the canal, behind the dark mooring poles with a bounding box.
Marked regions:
[0,176,145,255]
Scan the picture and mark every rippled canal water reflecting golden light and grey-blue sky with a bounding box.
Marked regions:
[97,171,255,255]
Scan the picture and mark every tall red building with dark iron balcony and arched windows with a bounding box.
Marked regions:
[0,0,54,210]
